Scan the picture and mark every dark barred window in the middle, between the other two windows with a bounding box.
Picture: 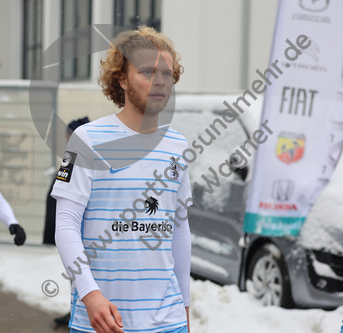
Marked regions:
[62,0,92,81]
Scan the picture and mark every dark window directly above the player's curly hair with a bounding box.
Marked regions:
[114,0,161,31]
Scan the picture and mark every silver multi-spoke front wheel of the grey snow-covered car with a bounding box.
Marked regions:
[246,244,293,308]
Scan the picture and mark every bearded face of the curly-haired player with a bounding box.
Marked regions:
[125,49,173,114]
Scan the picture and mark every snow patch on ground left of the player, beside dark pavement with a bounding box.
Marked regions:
[0,244,70,314]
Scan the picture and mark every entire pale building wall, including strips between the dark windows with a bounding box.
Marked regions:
[0,0,277,91]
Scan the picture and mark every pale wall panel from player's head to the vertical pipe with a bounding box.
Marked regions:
[162,0,243,90]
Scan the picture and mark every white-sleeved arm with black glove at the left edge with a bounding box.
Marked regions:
[0,193,26,246]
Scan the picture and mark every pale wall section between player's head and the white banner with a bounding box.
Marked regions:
[162,0,278,91]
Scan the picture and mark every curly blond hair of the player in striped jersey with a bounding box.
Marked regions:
[98,25,184,108]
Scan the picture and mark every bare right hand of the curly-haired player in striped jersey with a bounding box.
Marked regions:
[82,290,124,333]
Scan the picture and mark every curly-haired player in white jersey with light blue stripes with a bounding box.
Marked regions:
[52,26,191,333]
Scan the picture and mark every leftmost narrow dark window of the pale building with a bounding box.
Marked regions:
[23,0,43,80]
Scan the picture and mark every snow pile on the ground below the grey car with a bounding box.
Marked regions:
[190,281,343,333]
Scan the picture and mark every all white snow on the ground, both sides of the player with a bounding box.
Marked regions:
[0,244,343,333]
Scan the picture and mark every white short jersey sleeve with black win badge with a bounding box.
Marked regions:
[51,126,94,207]
